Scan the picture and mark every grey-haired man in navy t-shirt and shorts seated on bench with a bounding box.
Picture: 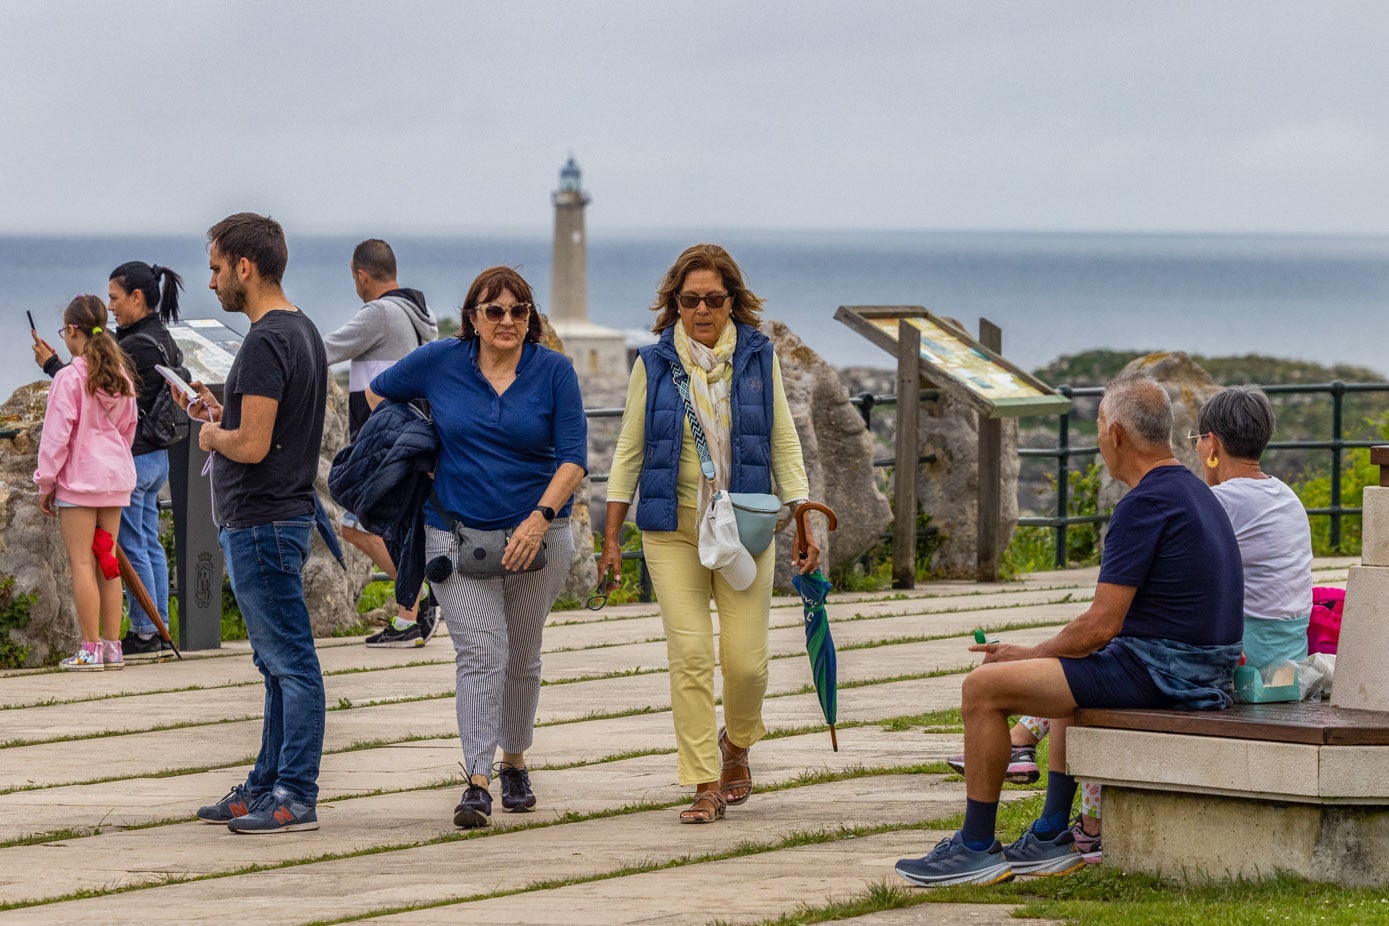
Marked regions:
[897,378,1245,887]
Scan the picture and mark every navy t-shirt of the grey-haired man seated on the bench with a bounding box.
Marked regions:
[1100,465,1245,646]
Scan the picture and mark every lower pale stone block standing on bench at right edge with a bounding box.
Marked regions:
[1331,566,1389,711]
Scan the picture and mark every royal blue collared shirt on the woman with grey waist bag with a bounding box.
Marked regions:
[371,337,589,530]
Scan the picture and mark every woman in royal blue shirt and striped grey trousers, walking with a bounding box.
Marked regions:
[371,267,588,829]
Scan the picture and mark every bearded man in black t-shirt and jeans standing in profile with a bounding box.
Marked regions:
[170,212,328,833]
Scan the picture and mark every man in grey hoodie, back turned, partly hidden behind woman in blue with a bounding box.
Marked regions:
[324,237,439,647]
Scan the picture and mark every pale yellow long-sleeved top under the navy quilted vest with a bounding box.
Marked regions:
[607,357,810,508]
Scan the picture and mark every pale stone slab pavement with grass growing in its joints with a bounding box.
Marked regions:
[0,559,1351,926]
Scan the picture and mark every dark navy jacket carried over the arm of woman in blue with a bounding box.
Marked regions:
[328,401,439,608]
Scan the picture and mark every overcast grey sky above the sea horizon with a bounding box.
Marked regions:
[0,0,1389,235]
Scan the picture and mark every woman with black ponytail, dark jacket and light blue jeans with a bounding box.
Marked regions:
[33,261,183,655]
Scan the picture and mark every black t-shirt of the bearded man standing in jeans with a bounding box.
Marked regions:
[213,310,328,528]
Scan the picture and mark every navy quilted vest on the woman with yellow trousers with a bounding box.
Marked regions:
[636,322,775,530]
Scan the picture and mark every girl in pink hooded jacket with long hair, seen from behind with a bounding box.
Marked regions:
[33,296,139,672]
